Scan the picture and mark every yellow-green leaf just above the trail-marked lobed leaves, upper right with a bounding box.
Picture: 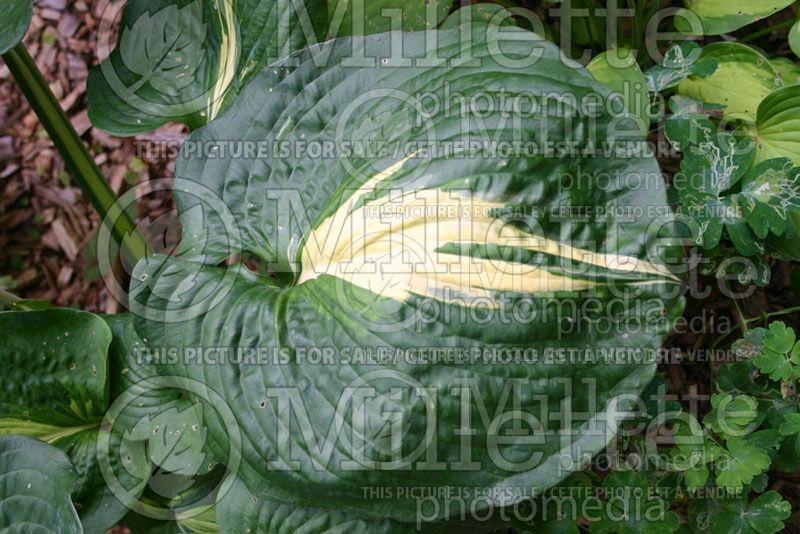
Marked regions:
[678,42,782,122]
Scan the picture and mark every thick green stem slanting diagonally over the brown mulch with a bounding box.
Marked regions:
[3,43,147,262]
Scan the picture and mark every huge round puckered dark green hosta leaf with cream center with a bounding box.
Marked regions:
[131,26,681,522]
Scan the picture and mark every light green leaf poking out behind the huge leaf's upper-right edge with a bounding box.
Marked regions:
[586,48,650,135]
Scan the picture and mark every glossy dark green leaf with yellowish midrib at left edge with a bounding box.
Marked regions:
[0,309,131,530]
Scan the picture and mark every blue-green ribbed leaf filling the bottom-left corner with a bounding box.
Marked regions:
[0,436,83,534]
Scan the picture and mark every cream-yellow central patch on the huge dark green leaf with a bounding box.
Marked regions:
[298,155,678,305]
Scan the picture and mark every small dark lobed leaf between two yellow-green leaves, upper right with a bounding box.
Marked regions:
[644,41,719,93]
